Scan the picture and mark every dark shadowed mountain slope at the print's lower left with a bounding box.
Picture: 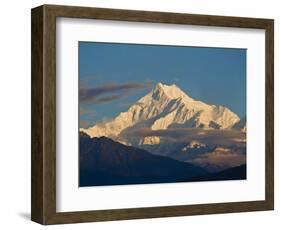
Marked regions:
[79,133,206,186]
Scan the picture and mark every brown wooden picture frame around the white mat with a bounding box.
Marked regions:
[31,5,274,224]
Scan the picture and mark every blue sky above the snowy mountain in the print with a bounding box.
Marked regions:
[79,42,246,127]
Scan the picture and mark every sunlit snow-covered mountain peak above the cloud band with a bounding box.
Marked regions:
[81,83,240,140]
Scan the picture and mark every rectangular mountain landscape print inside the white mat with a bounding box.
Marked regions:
[78,41,247,187]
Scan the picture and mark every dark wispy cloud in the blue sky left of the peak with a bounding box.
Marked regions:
[79,83,149,104]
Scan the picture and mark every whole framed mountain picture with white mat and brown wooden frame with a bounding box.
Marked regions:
[31,5,274,224]
